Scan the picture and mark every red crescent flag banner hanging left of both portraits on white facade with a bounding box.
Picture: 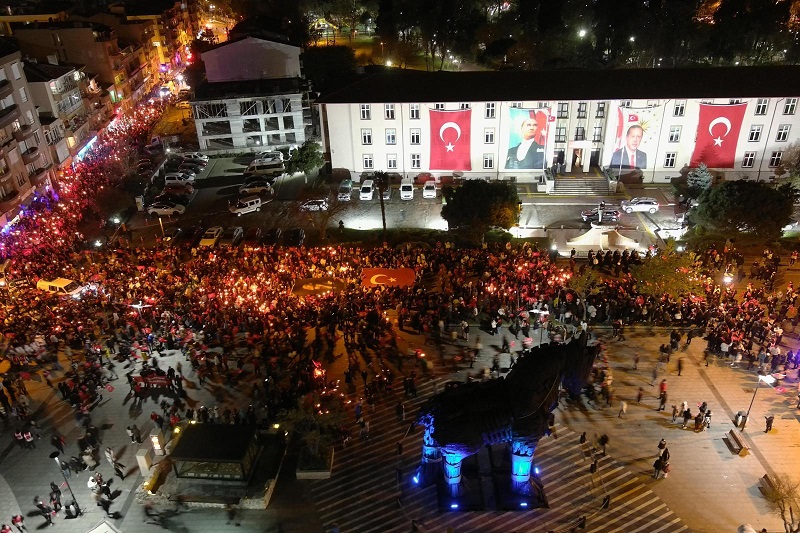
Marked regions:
[429,109,472,170]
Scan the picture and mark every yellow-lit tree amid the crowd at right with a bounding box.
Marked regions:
[631,239,702,298]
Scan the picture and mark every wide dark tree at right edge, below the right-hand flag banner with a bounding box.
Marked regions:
[691,180,798,241]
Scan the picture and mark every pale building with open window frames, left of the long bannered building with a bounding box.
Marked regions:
[191,37,306,154]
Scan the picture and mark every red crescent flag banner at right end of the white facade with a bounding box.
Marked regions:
[689,103,747,168]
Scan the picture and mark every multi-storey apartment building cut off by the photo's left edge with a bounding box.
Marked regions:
[0,38,55,228]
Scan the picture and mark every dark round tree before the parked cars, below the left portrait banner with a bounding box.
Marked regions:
[442,180,519,242]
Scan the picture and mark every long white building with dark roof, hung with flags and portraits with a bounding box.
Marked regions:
[317,66,800,188]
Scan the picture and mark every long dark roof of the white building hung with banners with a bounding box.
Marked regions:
[317,65,800,104]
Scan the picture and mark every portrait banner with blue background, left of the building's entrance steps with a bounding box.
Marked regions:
[505,108,549,170]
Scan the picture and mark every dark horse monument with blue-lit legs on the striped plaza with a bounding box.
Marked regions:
[414,333,595,509]
